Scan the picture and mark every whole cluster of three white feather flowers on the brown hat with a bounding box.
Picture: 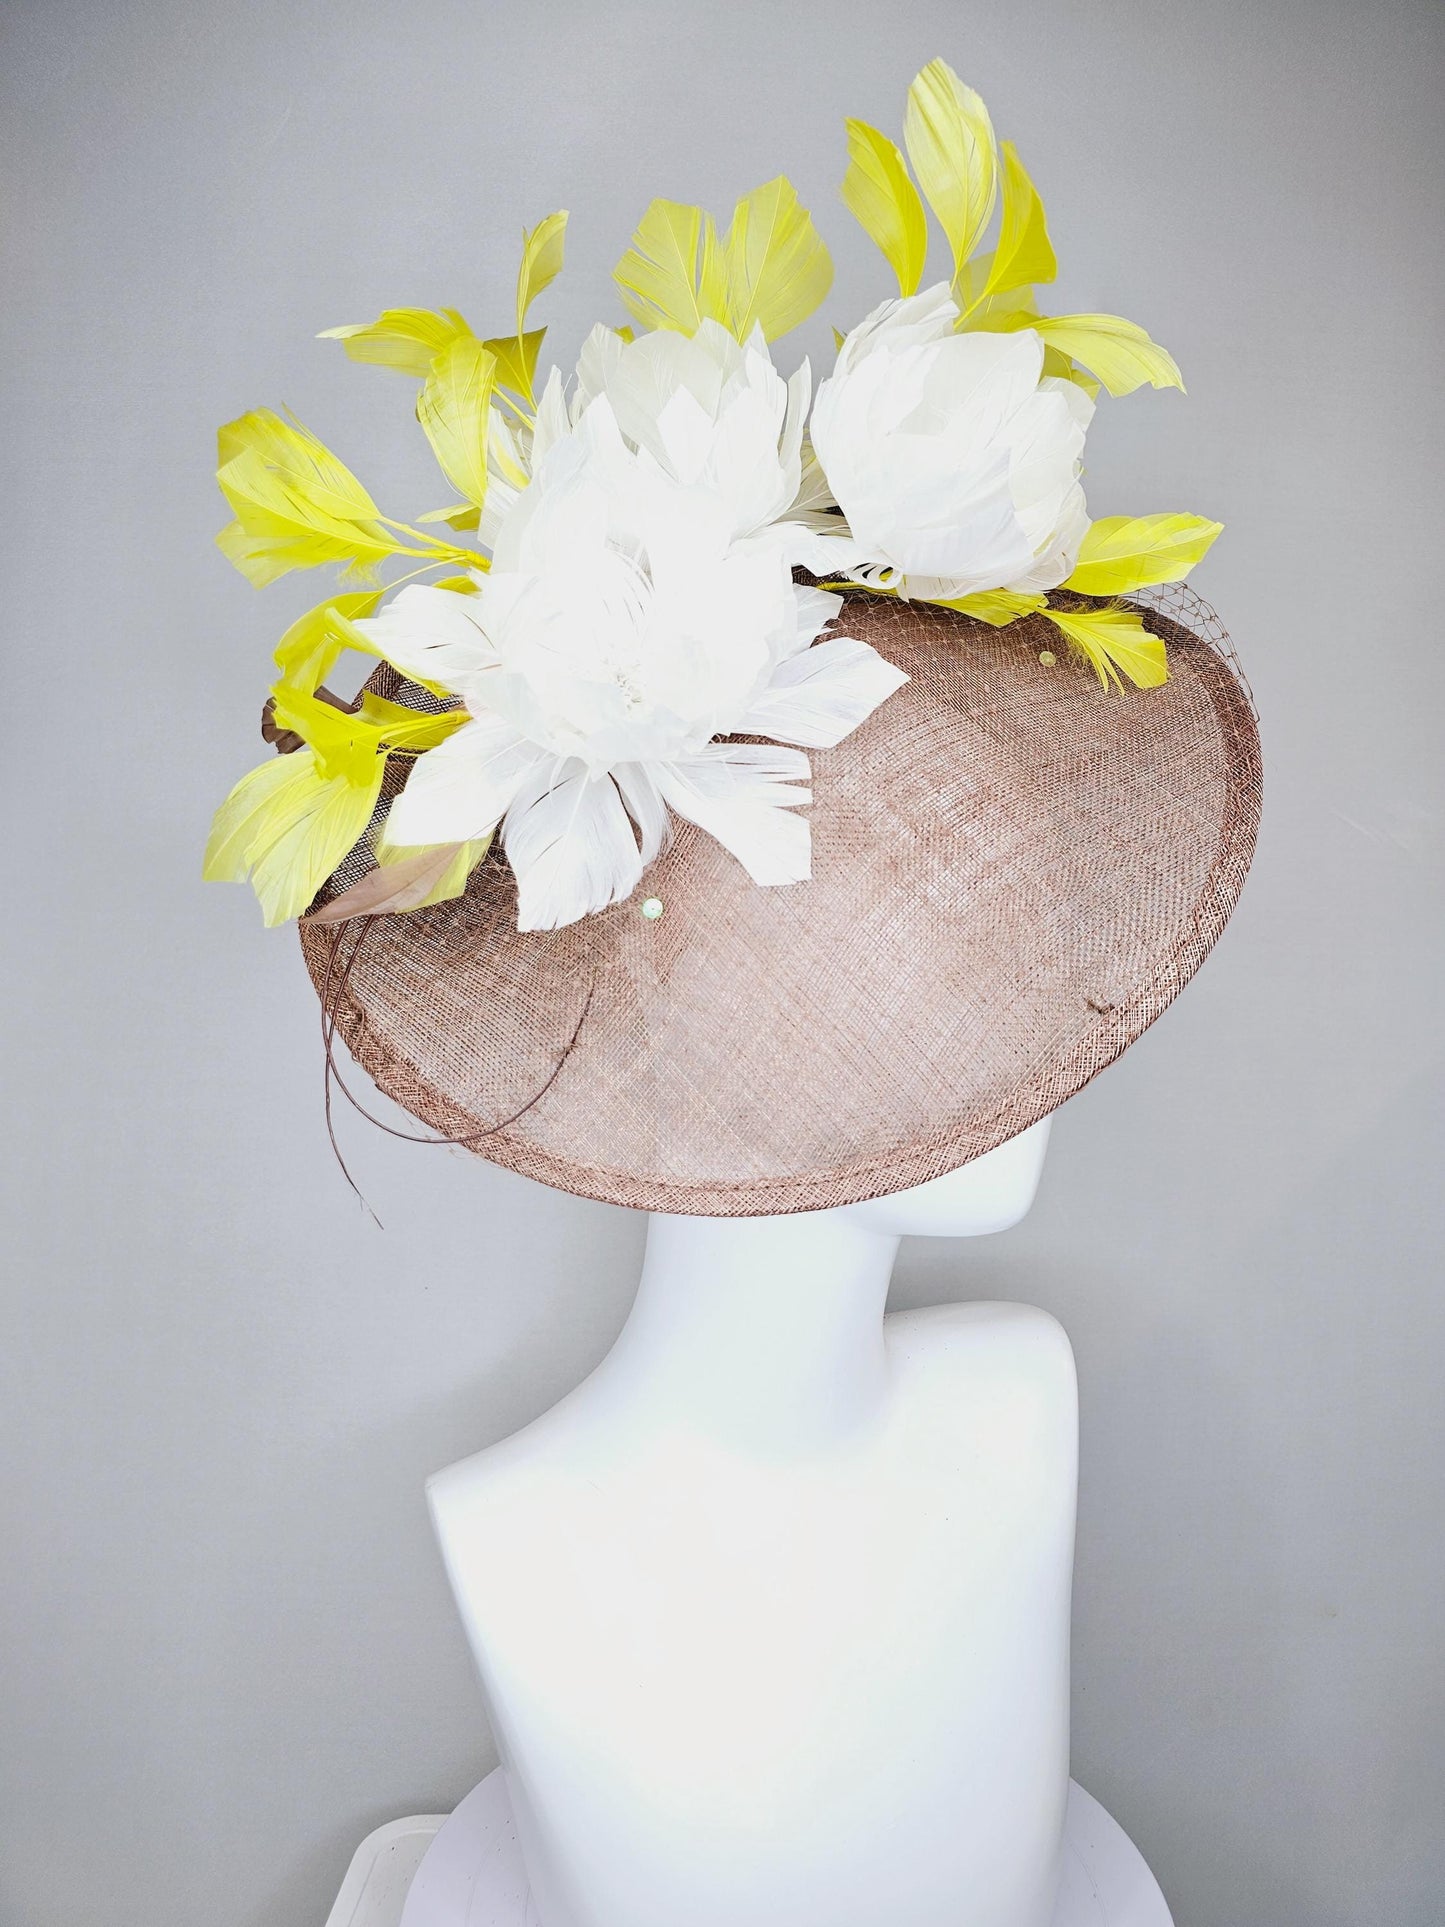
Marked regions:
[360,287,1092,931]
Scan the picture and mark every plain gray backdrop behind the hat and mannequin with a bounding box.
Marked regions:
[0,0,1445,1927]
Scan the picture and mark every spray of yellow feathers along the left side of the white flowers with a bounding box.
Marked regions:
[202,214,566,923]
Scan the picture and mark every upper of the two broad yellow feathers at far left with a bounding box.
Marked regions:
[216,409,399,588]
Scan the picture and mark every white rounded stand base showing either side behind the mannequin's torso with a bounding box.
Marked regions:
[326,1773,1173,1927]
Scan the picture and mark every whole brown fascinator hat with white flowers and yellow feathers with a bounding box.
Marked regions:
[206,62,1260,1216]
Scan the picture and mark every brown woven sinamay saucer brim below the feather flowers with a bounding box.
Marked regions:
[301,588,1260,1216]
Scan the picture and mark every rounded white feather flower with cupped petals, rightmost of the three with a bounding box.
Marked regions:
[807,285,1094,599]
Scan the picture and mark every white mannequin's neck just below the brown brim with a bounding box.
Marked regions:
[603,1212,898,1451]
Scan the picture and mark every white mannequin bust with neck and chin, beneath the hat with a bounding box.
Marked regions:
[428,1122,1077,1927]
